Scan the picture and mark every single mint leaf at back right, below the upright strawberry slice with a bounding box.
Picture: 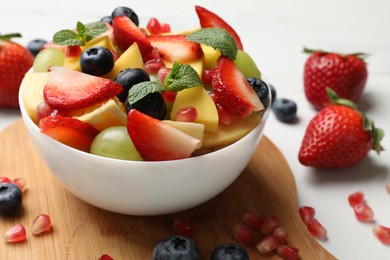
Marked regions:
[186,28,237,60]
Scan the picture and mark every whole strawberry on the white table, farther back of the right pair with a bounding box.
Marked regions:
[303,49,368,110]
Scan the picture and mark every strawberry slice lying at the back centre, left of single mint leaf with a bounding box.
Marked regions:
[148,35,203,63]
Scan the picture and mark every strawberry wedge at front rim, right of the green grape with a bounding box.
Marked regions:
[127,109,199,161]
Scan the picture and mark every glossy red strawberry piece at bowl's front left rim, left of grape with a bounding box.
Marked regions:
[39,115,99,152]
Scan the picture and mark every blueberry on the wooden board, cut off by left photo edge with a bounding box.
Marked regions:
[0,182,23,216]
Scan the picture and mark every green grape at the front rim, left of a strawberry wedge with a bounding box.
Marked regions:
[91,126,142,161]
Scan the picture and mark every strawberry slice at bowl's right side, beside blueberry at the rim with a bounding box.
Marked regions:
[211,56,264,117]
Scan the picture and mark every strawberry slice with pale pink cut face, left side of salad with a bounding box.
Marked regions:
[43,66,123,111]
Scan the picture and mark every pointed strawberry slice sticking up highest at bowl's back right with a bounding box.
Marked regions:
[195,6,243,50]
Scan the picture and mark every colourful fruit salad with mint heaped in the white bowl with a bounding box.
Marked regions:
[22,6,271,161]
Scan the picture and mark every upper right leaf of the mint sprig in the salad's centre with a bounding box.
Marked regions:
[164,62,203,92]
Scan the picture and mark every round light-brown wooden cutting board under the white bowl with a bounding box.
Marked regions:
[0,121,335,260]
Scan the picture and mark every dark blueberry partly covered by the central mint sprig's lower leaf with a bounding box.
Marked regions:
[126,92,167,120]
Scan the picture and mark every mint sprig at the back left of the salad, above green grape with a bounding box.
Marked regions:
[53,22,108,46]
